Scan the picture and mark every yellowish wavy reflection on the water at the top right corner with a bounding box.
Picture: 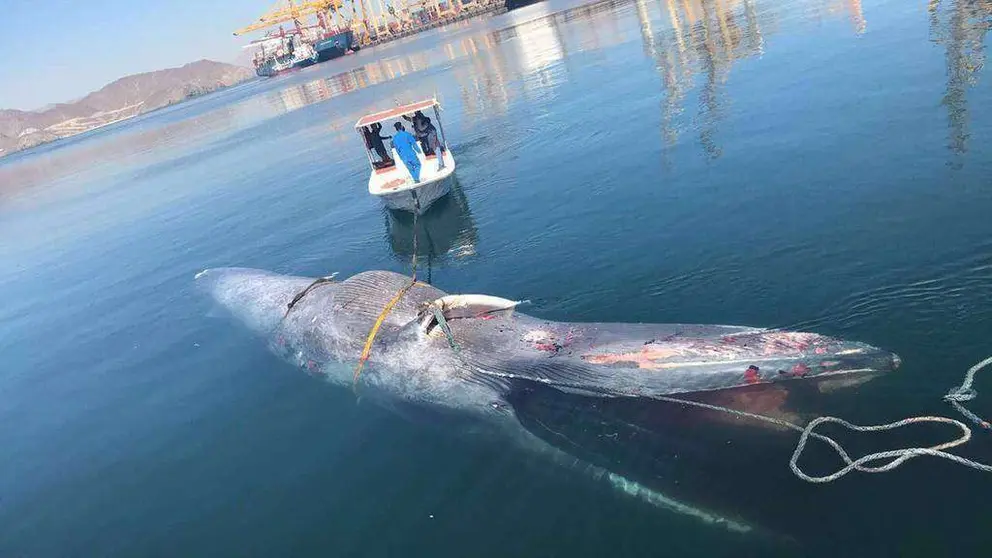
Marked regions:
[927,0,992,160]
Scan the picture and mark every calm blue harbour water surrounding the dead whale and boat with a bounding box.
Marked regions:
[0,0,992,558]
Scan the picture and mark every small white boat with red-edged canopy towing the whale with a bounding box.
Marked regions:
[355,99,455,214]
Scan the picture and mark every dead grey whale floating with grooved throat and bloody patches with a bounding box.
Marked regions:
[195,268,900,533]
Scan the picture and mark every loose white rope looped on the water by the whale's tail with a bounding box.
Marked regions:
[657,357,992,484]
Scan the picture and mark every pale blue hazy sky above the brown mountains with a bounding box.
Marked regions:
[0,0,275,109]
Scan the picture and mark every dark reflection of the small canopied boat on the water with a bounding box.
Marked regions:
[384,177,479,265]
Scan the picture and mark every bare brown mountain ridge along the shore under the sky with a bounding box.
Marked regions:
[0,60,255,156]
